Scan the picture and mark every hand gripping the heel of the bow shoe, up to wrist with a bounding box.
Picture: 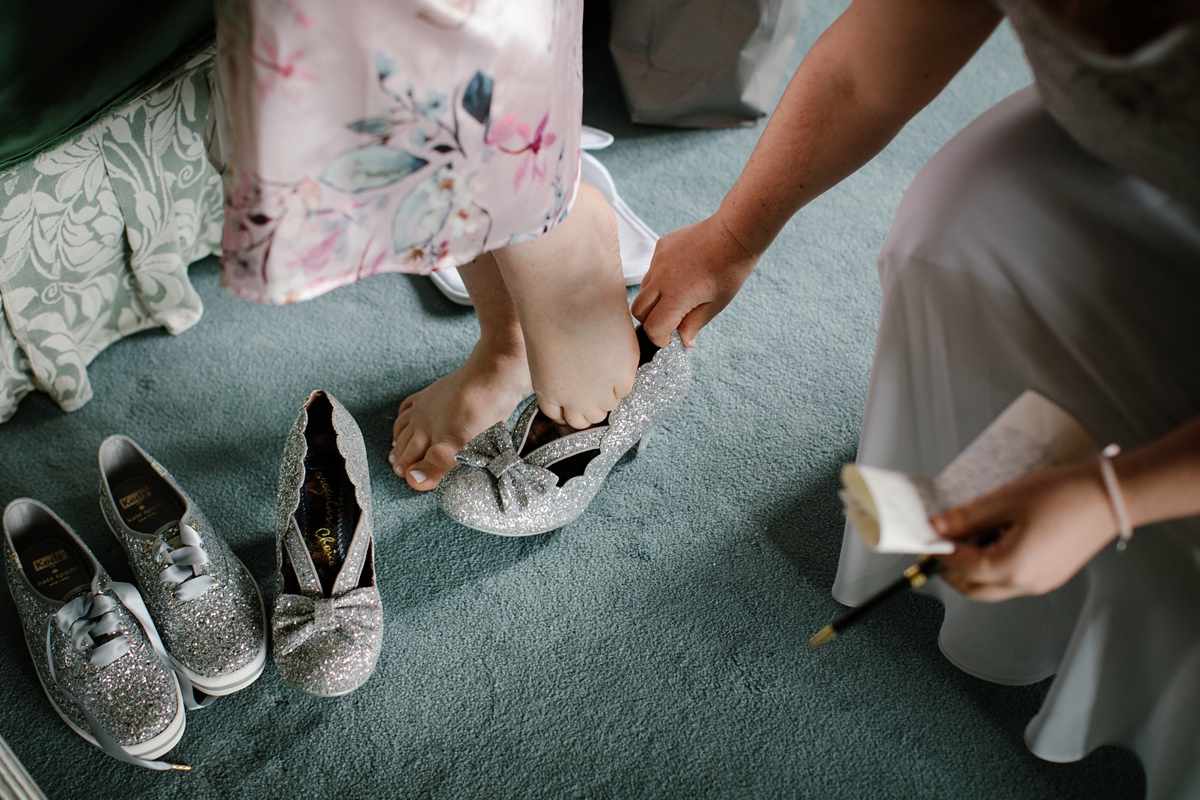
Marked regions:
[632,212,758,347]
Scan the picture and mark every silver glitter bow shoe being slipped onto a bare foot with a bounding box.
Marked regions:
[437,327,691,536]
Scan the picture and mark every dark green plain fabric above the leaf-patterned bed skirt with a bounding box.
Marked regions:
[0,0,212,167]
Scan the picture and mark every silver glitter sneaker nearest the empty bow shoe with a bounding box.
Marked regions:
[100,435,266,709]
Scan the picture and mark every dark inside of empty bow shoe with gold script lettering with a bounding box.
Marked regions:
[288,397,359,597]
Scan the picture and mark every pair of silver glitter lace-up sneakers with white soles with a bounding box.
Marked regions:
[2,435,266,770]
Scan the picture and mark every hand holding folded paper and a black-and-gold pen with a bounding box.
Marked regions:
[930,463,1117,602]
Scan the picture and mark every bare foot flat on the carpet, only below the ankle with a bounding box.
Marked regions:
[388,339,533,492]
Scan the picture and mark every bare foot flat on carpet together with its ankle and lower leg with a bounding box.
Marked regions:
[388,254,533,492]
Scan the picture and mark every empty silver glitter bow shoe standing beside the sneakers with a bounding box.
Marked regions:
[271,391,383,697]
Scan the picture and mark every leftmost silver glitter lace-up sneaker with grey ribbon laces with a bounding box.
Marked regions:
[4,499,187,770]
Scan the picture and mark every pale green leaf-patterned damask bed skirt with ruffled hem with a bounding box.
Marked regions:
[0,47,222,422]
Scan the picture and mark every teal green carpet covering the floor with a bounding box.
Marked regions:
[0,0,1144,800]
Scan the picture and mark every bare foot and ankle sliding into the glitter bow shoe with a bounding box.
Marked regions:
[493,184,638,428]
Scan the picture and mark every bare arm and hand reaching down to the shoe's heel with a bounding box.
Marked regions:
[634,0,1001,344]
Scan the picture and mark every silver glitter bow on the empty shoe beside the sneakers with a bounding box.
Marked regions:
[271,587,382,655]
